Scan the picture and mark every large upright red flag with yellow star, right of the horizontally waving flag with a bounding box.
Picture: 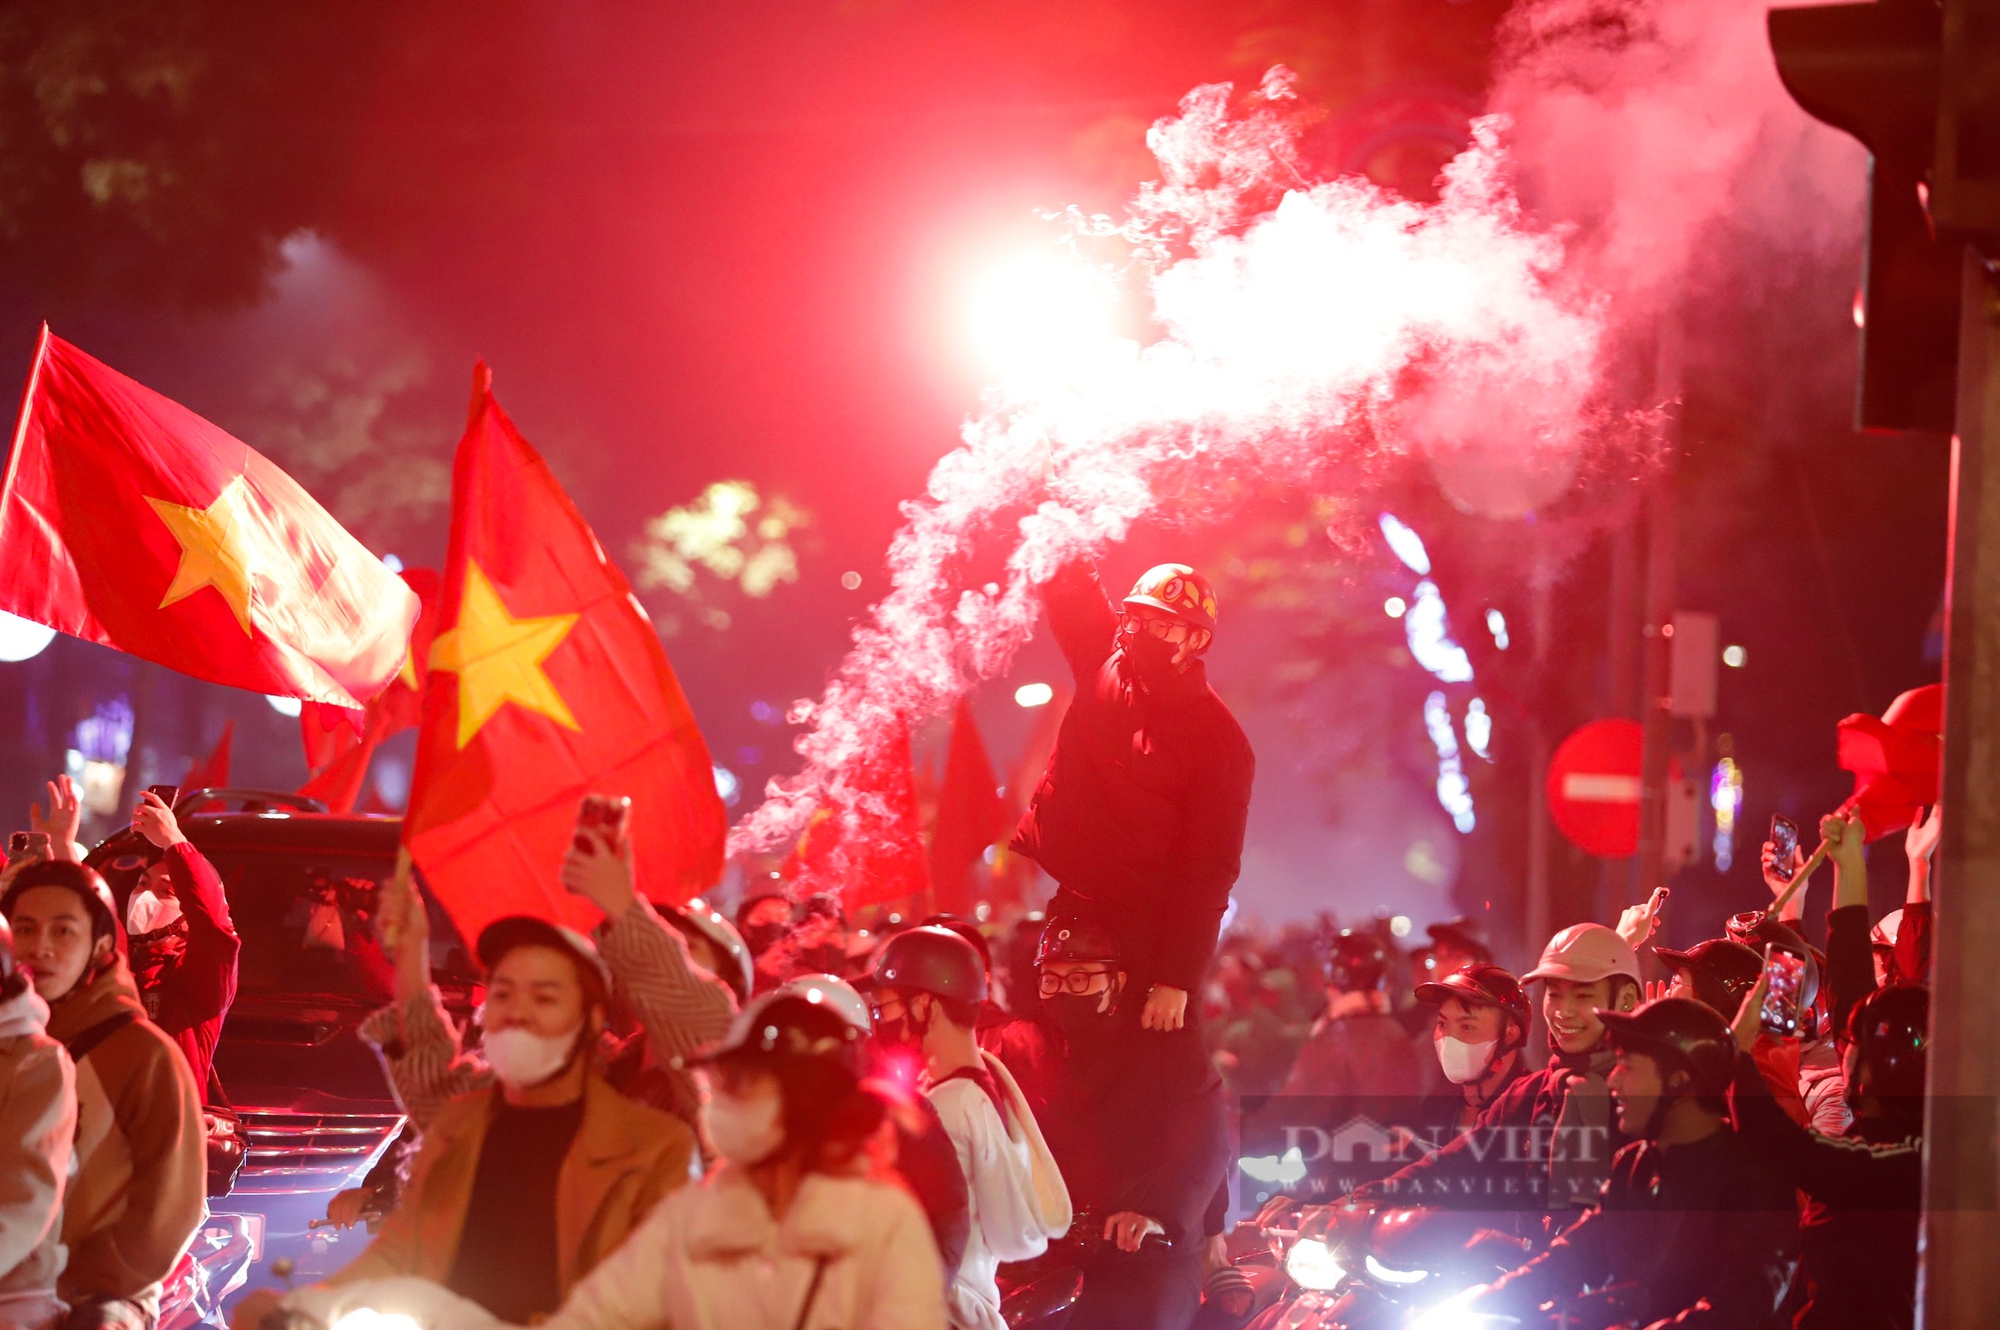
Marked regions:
[402,364,726,942]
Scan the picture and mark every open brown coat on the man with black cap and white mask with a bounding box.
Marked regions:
[328,1074,694,1294]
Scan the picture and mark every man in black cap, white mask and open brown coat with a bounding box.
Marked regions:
[232,914,694,1328]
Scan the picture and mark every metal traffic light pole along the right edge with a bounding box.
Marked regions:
[1918,246,2000,1330]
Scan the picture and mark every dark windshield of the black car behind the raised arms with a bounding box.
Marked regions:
[210,850,478,1002]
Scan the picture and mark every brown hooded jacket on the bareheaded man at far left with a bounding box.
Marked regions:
[48,954,208,1312]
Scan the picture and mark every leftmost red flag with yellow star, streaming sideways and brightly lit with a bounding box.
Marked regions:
[0,324,416,706]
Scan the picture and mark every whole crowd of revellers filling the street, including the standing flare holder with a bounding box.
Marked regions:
[0,564,1940,1330]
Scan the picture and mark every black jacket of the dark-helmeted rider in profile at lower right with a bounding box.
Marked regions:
[1476,1120,1798,1330]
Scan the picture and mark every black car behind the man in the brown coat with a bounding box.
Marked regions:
[88,788,480,1286]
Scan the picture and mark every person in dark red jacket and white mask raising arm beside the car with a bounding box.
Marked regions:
[126,790,242,1092]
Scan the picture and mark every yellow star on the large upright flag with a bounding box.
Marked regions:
[430,560,580,748]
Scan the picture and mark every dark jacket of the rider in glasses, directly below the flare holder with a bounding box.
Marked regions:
[1040,1012,1230,1252]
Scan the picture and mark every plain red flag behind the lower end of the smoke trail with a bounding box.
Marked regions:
[784,726,930,912]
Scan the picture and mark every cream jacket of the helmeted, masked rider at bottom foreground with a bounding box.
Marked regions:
[540,1164,944,1330]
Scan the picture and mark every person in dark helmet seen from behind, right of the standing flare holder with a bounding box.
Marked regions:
[1282,928,1422,1098]
